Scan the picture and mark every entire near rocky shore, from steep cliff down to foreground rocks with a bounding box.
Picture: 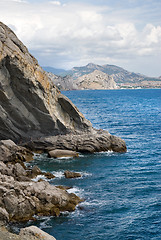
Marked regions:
[0,22,126,240]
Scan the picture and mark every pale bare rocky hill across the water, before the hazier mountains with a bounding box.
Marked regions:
[76,70,117,89]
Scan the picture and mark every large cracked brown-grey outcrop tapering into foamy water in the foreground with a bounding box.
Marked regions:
[0,173,81,221]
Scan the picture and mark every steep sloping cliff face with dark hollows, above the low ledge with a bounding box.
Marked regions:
[0,22,91,141]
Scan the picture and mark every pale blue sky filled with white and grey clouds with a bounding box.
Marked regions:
[0,0,161,76]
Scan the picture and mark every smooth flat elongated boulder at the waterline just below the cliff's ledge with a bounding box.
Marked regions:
[48,149,79,158]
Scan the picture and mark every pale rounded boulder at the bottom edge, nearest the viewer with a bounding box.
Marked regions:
[19,226,56,240]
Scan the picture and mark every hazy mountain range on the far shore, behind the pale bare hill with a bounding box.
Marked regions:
[45,63,161,90]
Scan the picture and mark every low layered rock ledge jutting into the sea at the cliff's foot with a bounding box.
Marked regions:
[25,130,126,153]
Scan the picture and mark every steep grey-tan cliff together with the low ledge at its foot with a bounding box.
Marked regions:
[0,22,126,152]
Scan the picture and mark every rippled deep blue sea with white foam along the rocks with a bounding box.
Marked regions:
[18,89,161,240]
